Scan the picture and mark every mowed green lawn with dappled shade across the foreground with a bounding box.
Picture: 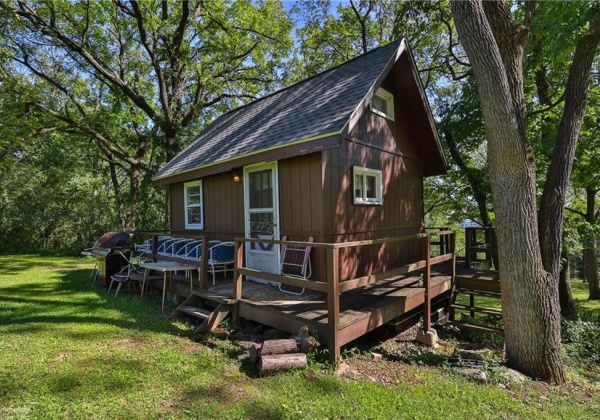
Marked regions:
[0,256,600,419]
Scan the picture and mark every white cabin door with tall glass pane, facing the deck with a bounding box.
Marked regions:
[244,162,279,284]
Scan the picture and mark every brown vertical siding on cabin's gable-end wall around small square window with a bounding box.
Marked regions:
[322,83,424,280]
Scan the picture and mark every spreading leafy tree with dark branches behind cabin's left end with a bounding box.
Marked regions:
[0,0,291,229]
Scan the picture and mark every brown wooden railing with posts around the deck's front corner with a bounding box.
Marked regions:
[233,230,456,362]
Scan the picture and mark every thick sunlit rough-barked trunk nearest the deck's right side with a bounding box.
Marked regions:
[452,1,565,383]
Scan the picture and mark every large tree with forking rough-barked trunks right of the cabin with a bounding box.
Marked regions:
[452,1,600,383]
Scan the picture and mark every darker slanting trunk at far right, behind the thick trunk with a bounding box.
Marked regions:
[539,12,600,298]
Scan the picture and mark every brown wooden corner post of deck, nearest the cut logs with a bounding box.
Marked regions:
[327,247,340,366]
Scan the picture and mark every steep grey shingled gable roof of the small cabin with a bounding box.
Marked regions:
[154,38,447,184]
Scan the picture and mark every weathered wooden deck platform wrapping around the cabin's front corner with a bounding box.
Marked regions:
[195,275,451,345]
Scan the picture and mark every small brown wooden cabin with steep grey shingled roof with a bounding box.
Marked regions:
[154,38,447,362]
